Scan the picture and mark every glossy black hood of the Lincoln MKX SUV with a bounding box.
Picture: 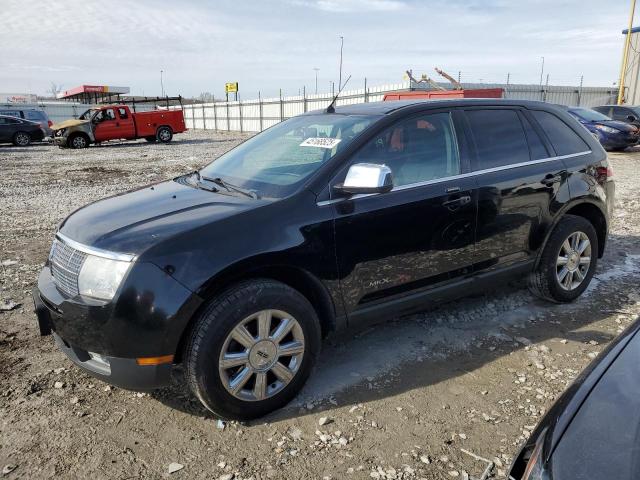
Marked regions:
[60,180,268,255]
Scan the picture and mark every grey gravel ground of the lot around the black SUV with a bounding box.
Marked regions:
[0,131,640,480]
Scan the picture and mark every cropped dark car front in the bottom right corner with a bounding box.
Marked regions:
[509,320,640,480]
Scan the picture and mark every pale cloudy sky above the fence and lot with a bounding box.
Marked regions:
[0,0,628,99]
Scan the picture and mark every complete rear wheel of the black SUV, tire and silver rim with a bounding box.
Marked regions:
[529,215,598,303]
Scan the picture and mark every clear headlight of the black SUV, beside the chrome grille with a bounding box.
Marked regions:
[78,255,132,300]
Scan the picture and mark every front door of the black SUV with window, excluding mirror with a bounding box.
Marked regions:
[334,112,476,313]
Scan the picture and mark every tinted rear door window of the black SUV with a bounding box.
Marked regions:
[466,109,530,170]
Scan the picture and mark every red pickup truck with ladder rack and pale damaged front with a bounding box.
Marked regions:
[51,105,187,148]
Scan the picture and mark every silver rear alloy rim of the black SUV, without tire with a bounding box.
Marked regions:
[556,232,591,290]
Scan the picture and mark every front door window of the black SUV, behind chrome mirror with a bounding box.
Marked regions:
[351,113,460,186]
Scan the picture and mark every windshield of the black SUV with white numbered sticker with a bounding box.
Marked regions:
[200,113,380,198]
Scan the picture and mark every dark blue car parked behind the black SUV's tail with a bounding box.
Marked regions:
[568,107,640,151]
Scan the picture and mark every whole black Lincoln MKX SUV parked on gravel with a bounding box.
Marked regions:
[34,100,614,419]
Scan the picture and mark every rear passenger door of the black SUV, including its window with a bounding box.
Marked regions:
[465,106,567,271]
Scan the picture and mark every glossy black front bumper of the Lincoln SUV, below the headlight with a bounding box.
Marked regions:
[33,263,202,390]
